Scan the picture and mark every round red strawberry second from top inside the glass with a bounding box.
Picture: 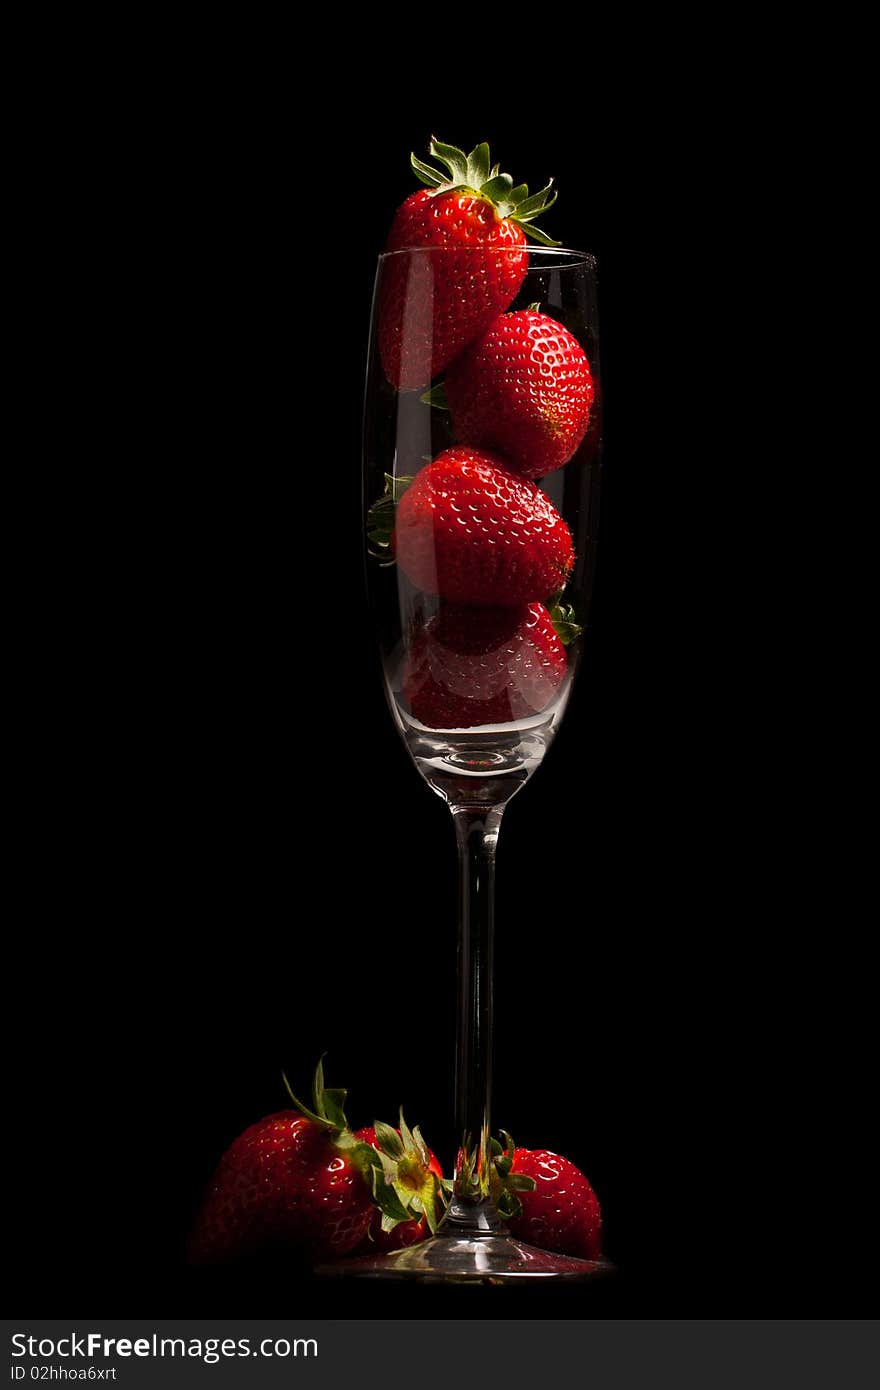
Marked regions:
[446,309,595,478]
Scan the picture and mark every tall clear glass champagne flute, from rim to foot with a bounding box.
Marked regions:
[341,247,603,1280]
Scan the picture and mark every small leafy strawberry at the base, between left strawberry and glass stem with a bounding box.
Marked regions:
[355,1112,445,1252]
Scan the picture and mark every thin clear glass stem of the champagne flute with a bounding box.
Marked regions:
[446,806,505,1229]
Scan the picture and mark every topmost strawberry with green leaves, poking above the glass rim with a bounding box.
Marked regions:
[378,139,559,391]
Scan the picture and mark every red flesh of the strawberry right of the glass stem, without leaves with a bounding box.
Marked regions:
[507,1148,602,1259]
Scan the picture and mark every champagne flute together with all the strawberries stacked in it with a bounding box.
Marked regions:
[353,140,601,1279]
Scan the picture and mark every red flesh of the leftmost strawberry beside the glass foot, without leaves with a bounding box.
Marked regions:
[189,1111,374,1264]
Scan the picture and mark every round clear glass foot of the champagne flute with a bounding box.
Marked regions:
[316,1234,613,1284]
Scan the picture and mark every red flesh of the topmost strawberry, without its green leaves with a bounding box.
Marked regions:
[378,189,528,391]
